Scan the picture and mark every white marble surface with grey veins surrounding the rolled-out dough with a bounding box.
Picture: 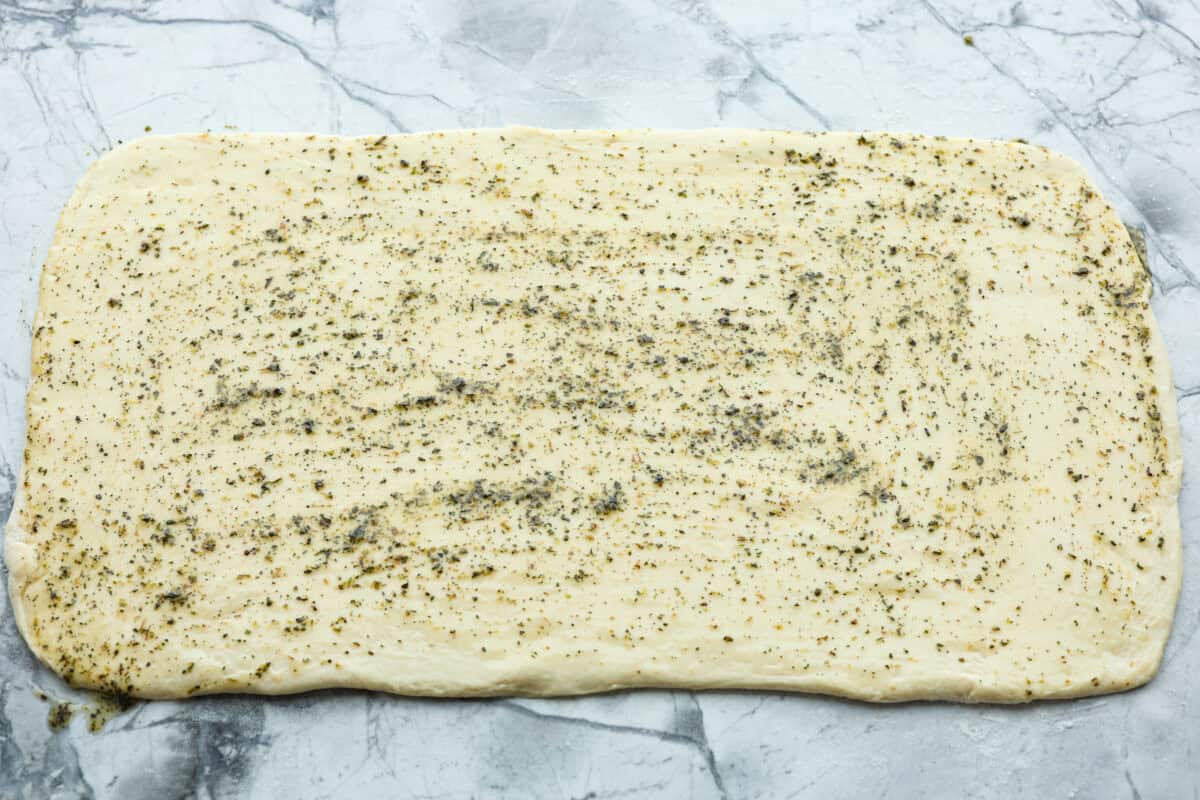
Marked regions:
[0,0,1200,800]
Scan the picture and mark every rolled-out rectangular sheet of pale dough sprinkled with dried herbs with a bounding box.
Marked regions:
[6,128,1181,702]
